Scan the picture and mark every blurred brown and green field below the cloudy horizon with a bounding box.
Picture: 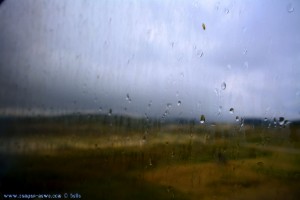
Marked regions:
[0,116,300,200]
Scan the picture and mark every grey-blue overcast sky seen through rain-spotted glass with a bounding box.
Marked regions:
[0,0,300,119]
